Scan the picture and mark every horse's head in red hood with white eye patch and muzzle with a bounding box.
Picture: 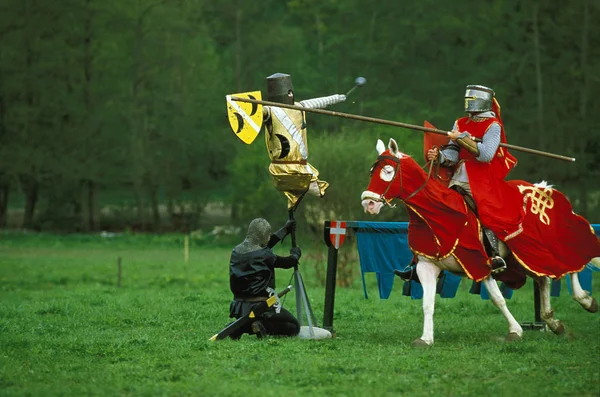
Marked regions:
[361,138,404,215]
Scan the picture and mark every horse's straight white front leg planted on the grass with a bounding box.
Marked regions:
[413,256,441,346]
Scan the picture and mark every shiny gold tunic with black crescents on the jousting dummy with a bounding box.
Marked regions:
[265,103,329,209]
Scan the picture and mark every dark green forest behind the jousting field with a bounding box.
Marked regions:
[0,0,600,238]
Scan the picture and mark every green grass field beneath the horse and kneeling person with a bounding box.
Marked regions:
[0,230,600,397]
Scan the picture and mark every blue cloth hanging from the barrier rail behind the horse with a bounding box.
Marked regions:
[353,221,600,299]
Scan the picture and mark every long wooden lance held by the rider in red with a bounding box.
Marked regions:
[231,96,575,162]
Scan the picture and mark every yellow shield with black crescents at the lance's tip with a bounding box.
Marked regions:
[225,91,263,145]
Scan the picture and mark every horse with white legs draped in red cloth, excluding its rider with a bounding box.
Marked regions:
[361,139,600,345]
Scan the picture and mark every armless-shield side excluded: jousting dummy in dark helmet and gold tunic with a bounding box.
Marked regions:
[263,73,346,209]
